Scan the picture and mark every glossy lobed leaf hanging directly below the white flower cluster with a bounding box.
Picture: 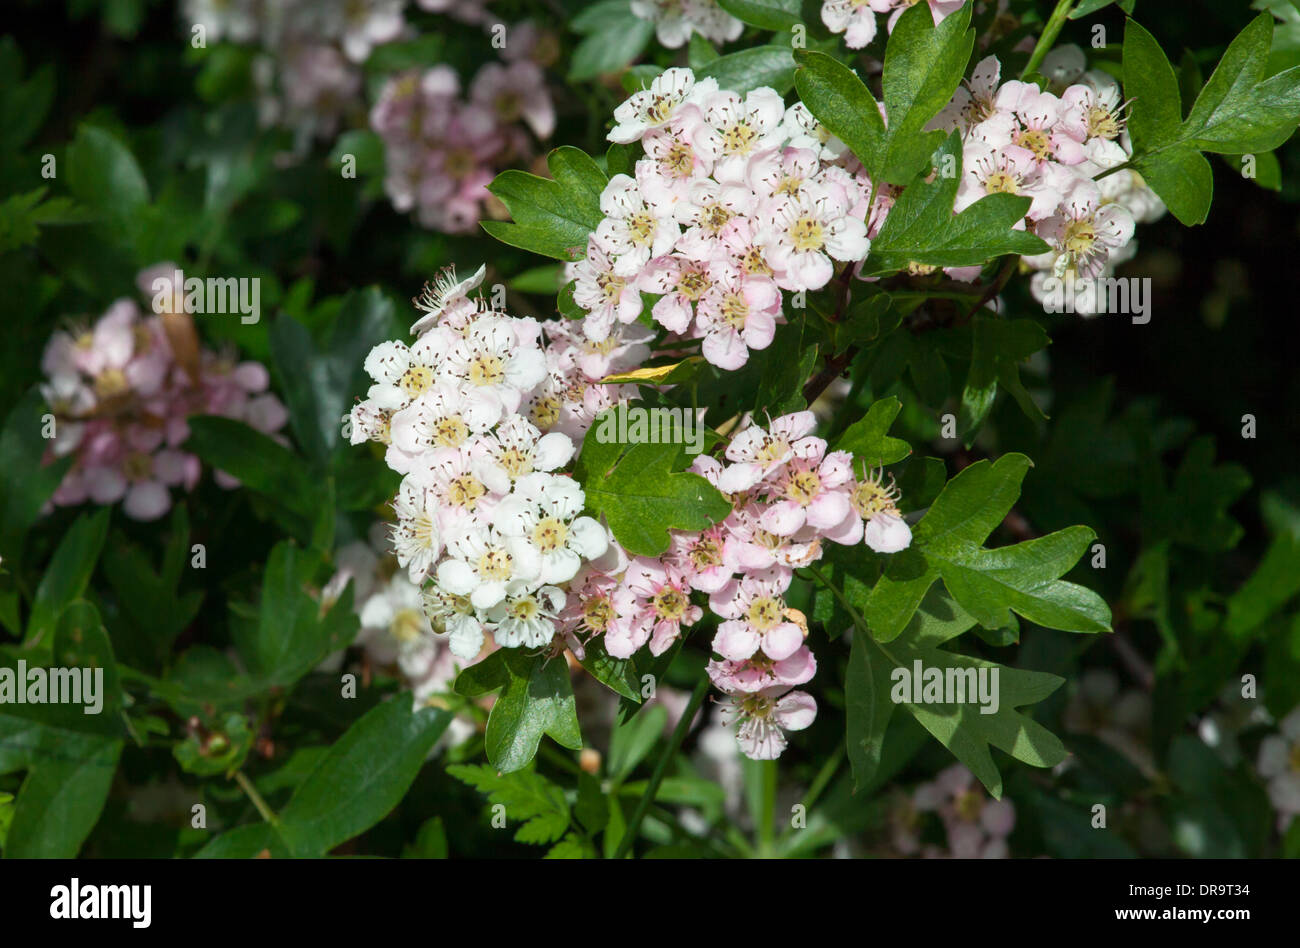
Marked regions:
[455,649,582,774]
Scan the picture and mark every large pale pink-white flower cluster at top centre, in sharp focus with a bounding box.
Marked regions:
[571,68,870,369]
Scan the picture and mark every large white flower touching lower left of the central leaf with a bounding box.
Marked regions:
[493,473,608,583]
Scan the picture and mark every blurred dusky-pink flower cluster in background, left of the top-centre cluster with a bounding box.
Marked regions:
[371,23,555,233]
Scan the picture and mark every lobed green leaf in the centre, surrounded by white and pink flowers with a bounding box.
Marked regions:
[575,408,731,557]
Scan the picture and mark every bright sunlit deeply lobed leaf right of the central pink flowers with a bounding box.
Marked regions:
[865,454,1110,642]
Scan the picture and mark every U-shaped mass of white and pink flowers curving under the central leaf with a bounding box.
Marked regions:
[348,254,911,758]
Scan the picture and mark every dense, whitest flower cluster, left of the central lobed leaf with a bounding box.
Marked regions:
[348,262,626,659]
